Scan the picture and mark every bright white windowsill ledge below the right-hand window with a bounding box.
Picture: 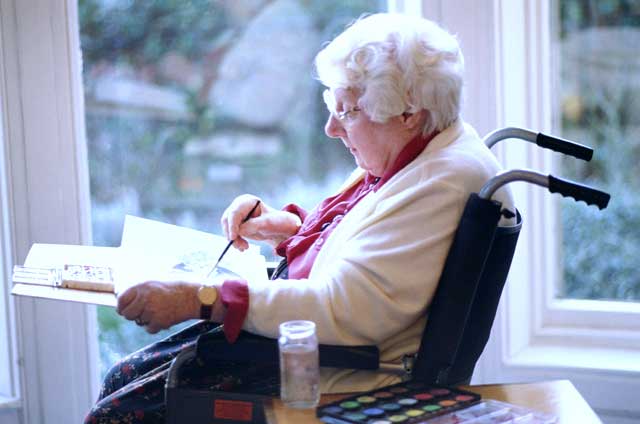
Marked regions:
[505,344,640,376]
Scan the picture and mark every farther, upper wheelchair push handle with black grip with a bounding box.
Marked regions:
[484,127,593,162]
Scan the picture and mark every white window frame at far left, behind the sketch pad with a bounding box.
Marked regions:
[0,0,99,423]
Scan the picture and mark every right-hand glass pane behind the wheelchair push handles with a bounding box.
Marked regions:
[555,0,640,301]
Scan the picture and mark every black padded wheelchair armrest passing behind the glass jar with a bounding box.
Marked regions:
[196,331,380,370]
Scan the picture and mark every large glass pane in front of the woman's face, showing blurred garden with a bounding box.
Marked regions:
[79,0,386,374]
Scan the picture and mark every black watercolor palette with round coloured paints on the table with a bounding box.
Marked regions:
[316,381,480,424]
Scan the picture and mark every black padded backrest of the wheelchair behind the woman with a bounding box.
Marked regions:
[412,194,522,385]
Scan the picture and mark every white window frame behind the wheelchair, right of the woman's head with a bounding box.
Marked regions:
[422,0,640,422]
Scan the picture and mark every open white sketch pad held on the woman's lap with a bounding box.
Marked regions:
[11,216,268,306]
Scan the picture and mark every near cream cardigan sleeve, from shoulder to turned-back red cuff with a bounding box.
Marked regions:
[245,171,478,345]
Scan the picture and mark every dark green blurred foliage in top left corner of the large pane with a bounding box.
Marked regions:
[78,0,228,67]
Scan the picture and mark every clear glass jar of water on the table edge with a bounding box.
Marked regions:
[278,321,320,408]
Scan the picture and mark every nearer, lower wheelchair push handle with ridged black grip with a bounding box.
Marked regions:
[478,169,611,209]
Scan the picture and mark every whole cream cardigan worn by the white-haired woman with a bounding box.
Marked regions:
[244,122,514,392]
